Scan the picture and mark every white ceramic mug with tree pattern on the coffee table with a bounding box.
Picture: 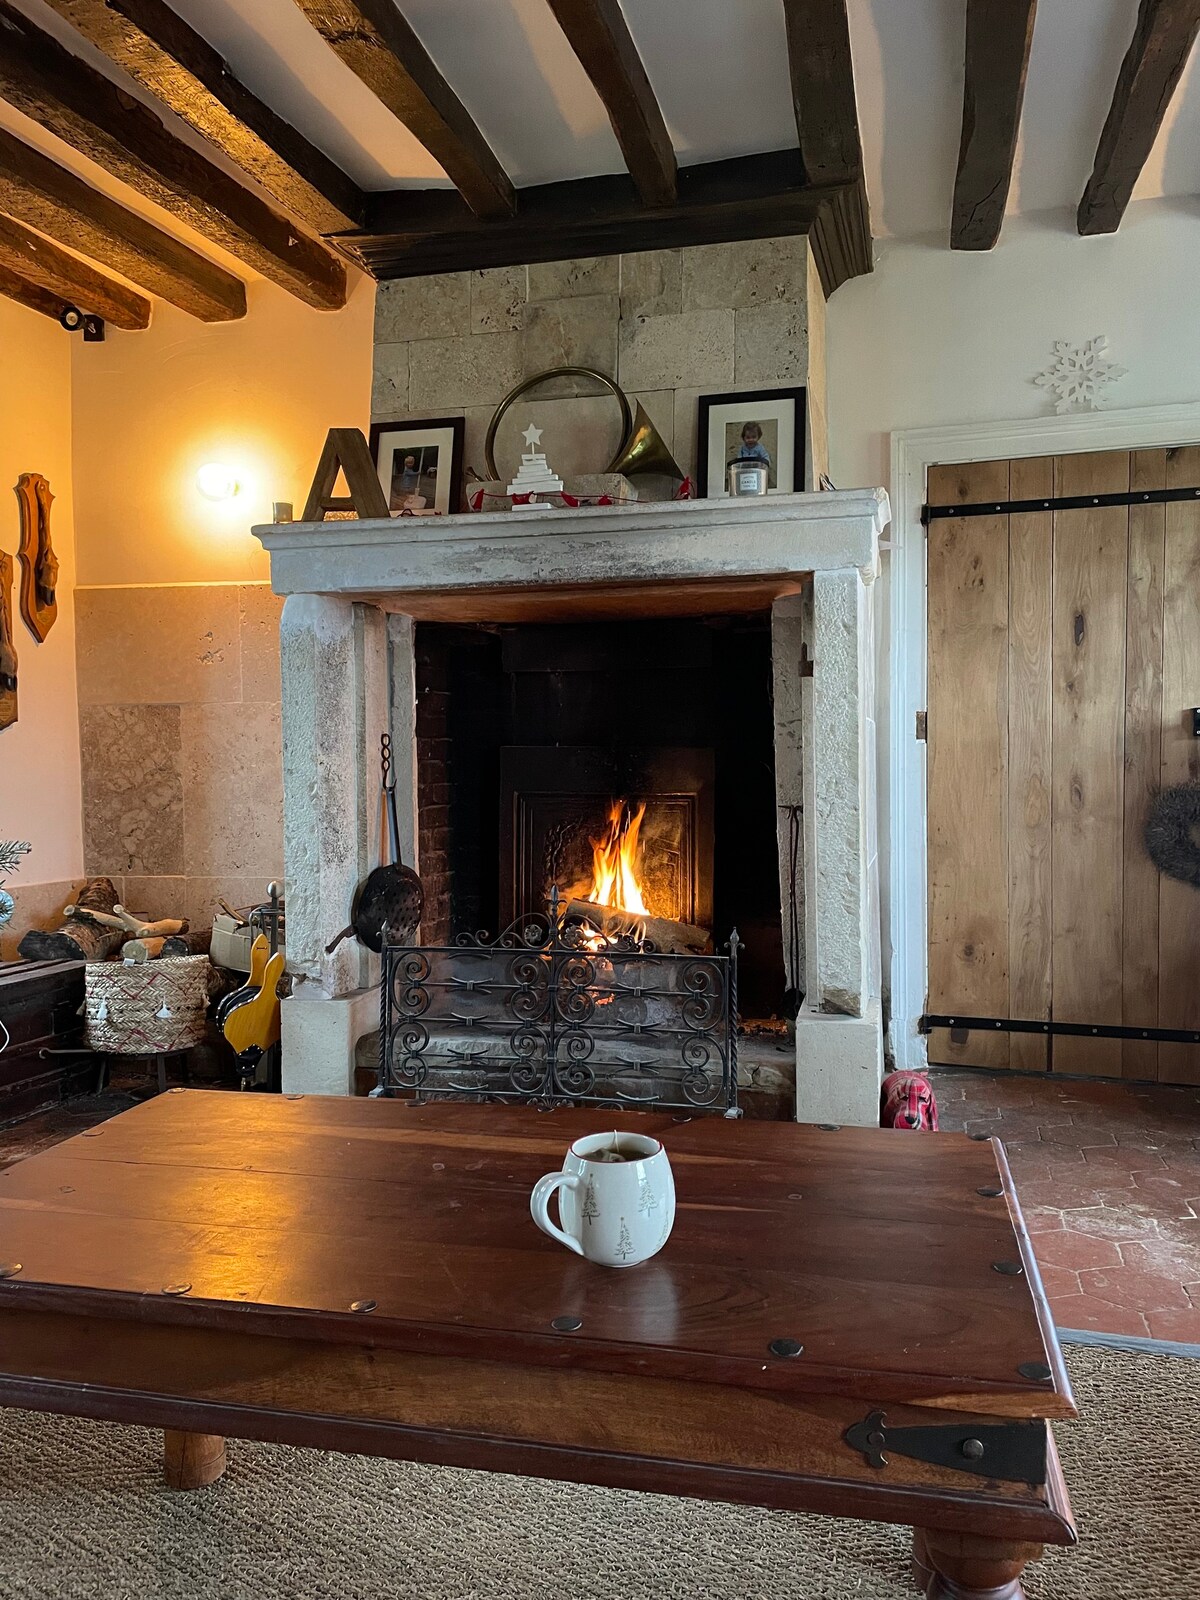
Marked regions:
[530,1133,675,1267]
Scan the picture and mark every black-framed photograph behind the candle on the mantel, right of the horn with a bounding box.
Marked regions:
[696,389,805,499]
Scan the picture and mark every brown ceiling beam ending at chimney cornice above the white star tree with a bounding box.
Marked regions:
[296,0,515,218]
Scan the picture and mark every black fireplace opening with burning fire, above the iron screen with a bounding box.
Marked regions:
[416,614,786,1019]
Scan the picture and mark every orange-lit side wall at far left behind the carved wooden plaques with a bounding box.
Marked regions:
[0,299,83,893]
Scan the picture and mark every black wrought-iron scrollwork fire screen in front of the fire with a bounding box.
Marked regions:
[382,893,741,1115]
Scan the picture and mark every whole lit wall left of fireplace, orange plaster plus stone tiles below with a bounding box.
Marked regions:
[65,268,374,926]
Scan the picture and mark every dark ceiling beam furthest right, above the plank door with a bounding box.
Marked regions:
[1075,0,1200,234]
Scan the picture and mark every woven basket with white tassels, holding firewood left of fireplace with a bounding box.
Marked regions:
[83,955,216,1056]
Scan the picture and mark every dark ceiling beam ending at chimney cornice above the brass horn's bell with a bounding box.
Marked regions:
[549,0,677,205]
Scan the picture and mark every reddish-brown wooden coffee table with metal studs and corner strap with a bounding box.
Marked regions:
[0,1090,1075,1600]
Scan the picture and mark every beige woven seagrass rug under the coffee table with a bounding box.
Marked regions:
[0,1347,1200,1600]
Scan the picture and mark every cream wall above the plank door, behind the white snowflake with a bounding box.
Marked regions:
[827,200,1200,488]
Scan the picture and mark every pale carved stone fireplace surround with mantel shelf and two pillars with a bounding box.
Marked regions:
[254,490,890,1125]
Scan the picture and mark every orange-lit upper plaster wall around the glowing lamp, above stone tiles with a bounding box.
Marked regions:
[74,272,374,586]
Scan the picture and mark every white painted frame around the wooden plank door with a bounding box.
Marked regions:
[880,402,1200,1070]
